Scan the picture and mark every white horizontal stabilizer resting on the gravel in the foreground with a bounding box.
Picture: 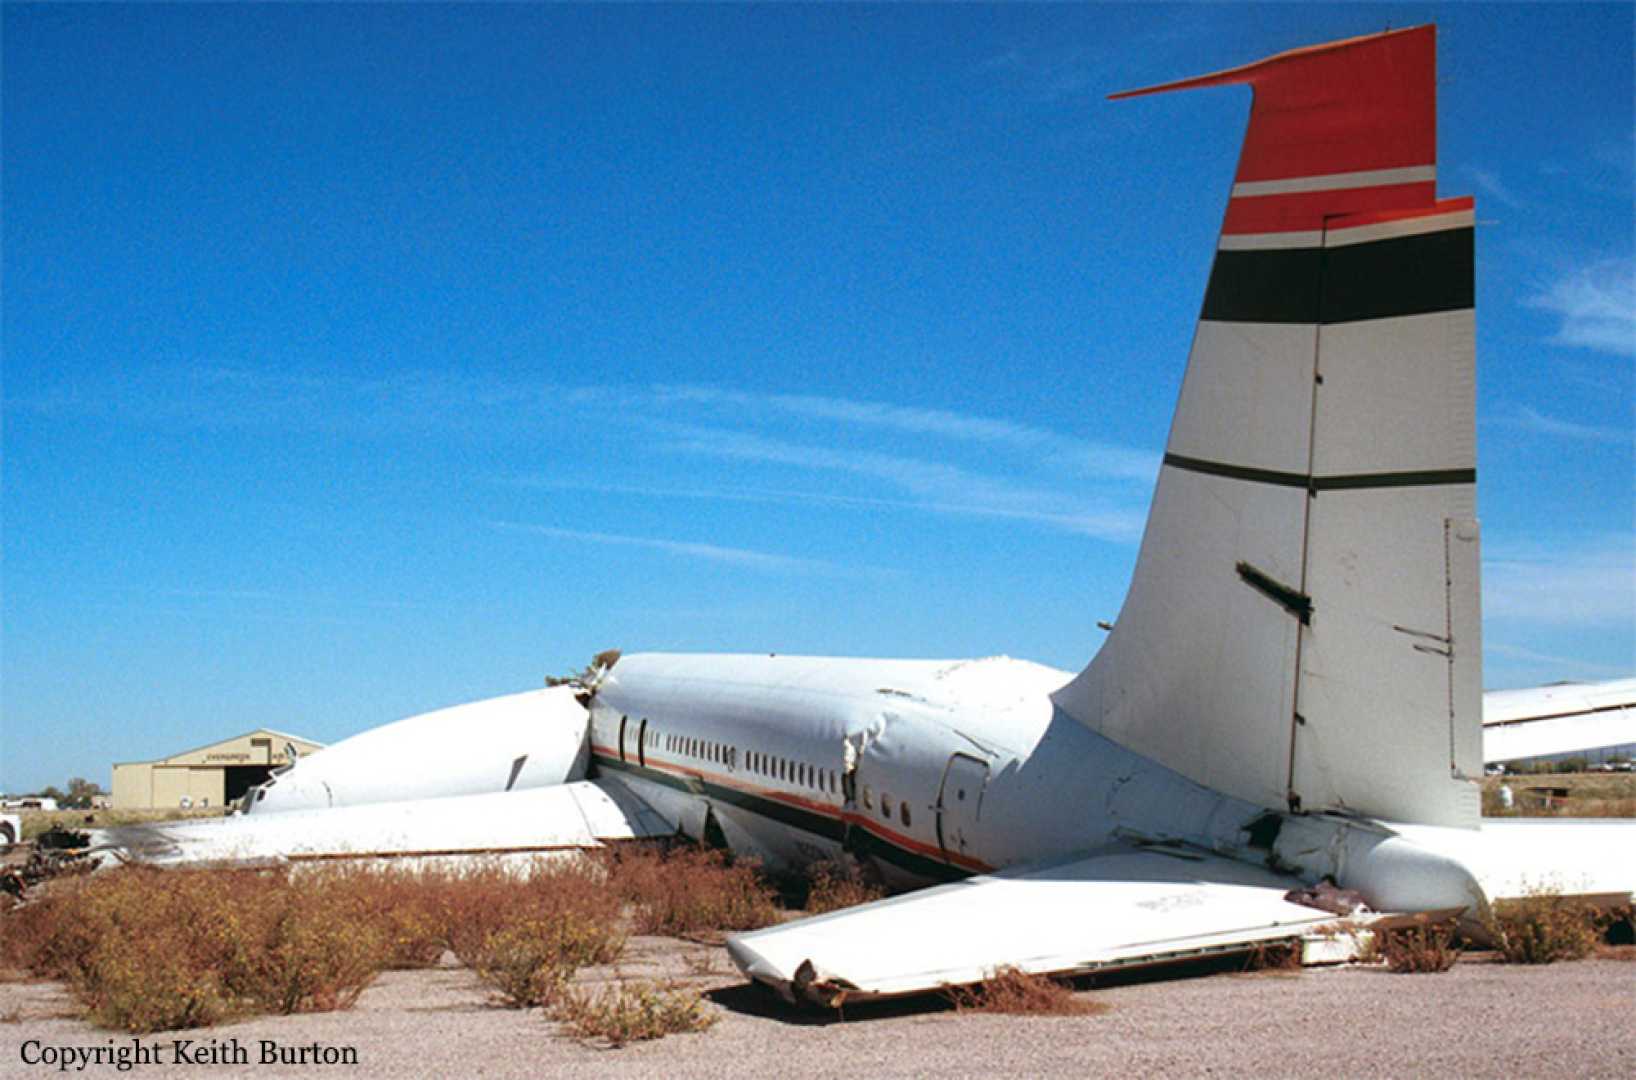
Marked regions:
[728,848,1338,1006]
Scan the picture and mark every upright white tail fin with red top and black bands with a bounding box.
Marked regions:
[1055,26,1482,826]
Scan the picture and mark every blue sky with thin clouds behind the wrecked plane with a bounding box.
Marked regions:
[0,3,1636,790]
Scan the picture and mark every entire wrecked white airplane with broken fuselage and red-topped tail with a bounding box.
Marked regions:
[121,26,1636,1005]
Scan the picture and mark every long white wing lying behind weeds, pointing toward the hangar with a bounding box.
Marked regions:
[100,781,676,864]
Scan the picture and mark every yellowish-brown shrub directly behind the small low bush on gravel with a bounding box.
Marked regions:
[473,913,625,1008]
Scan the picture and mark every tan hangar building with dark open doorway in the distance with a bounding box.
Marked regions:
[113,728,324,810]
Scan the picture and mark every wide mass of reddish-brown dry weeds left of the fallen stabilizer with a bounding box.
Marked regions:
[0,848,795,1044]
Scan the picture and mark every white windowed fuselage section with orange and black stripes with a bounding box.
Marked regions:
[591,655,1265,885]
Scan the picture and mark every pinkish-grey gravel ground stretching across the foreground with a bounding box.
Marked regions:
[0,938,1636,1080]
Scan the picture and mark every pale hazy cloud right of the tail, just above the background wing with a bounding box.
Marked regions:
[1482,537,1636,628]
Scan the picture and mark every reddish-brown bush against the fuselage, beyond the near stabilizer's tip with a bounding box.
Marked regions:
[605,848,779,936]
